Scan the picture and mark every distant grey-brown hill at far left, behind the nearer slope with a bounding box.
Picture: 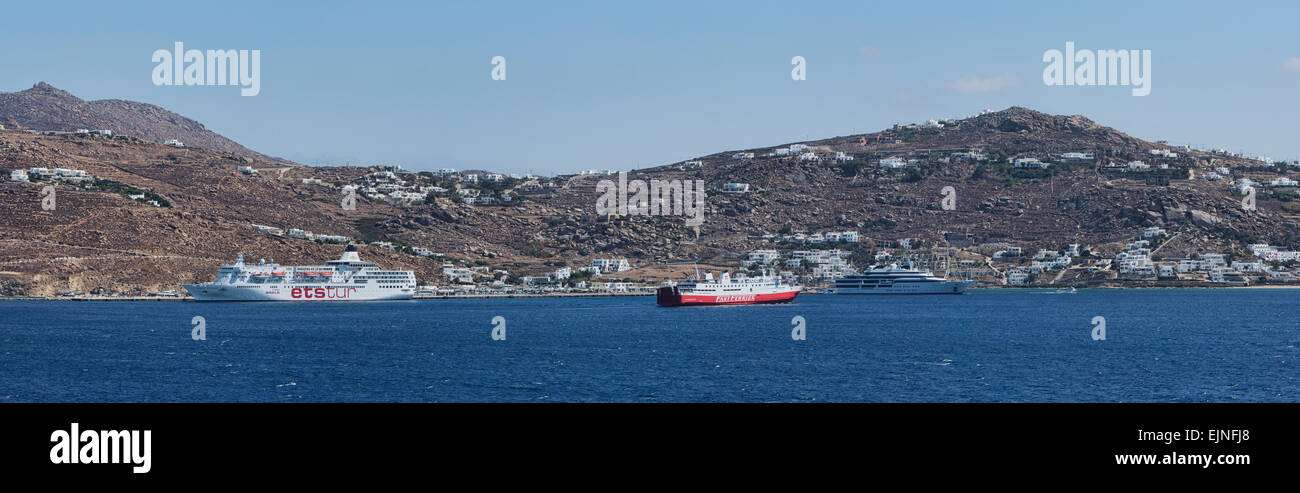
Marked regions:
[0,82,287,163]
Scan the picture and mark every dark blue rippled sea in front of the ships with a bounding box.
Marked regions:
[0,290,1300,402]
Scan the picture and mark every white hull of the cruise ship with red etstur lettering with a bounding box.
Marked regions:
[183,284,415,302]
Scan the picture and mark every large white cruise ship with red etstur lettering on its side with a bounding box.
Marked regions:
[185,245,416,302]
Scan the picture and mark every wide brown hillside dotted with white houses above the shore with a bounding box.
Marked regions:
[0,86,1300,295]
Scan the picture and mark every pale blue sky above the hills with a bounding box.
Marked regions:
[0,0,1300,174]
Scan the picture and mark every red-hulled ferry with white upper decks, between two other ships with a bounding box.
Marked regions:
[657,273,803,307]
